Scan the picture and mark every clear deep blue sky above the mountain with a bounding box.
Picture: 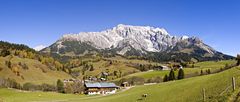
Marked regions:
[0,0,240,55]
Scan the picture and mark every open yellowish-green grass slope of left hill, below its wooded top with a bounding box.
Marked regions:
[0,56,71,84]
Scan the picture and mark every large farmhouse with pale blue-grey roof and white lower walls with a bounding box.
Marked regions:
[85,82,118,95]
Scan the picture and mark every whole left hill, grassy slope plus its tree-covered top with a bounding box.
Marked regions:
[0,41,72,85]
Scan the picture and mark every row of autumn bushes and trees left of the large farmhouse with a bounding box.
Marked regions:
[0,78,85,94]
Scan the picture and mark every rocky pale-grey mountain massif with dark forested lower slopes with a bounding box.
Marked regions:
[40,24,233,61]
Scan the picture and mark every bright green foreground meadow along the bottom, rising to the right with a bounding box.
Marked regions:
[0,67,240,102]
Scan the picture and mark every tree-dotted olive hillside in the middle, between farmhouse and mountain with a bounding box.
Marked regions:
[69,56,163,80]
